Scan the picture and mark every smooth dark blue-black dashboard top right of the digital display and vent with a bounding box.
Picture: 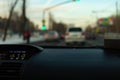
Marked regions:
[23,48,120,80]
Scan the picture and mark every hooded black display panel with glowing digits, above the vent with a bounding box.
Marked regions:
[0,45,43,60]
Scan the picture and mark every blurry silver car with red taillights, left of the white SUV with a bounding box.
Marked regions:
[44,31,60,41]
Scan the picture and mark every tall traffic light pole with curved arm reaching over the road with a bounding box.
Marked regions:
[42,0,80,30]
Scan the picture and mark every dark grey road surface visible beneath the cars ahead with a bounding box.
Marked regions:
[33,39,104,47]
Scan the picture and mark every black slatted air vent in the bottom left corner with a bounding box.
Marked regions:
[0,62,22,80]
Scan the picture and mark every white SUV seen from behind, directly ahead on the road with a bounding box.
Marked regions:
[65,27,85,45]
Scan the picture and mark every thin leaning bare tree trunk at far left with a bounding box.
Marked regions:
[3,0,18,41]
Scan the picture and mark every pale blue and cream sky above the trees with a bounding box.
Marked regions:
[0,0,119,27]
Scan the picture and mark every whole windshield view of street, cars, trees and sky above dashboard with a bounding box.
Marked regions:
[0,0,120,47]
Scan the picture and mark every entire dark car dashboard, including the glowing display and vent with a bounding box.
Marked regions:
[0,45,120,80]
